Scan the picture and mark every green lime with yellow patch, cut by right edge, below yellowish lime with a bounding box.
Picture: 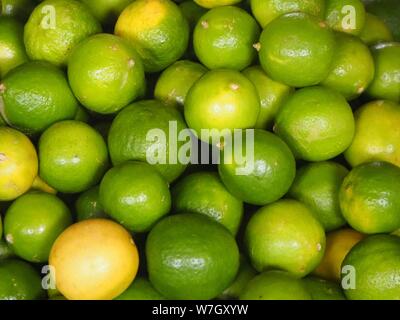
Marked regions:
[339,162,400,234]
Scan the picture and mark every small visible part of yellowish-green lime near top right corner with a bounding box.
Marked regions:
[360,12,393,46]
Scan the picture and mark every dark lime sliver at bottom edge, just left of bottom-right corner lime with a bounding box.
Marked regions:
[303,276,346,300]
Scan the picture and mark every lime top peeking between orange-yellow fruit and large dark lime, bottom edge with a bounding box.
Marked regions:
[114,277,165,300]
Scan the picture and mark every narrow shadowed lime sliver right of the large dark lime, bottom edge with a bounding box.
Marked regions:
[218,255,257,299]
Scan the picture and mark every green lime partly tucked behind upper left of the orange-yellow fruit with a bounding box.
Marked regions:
[4,192,72,263]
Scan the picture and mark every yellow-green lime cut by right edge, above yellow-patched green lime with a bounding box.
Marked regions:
[344,100,400,167]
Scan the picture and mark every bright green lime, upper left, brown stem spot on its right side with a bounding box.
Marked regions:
[68,34,145,114]
